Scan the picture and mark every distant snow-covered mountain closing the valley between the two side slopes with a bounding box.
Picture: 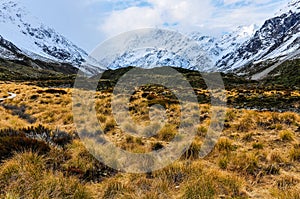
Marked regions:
[97,25,256,71]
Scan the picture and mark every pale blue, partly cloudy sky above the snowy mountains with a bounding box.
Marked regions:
[22,0,288,53]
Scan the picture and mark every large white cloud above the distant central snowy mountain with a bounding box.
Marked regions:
[99,0,214,36]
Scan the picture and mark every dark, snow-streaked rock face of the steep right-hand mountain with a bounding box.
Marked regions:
[217,11,300,70]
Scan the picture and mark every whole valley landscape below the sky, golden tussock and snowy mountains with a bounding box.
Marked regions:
[0,0,300,199]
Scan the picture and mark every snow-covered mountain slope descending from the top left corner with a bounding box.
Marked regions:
[0,0,99,74]
